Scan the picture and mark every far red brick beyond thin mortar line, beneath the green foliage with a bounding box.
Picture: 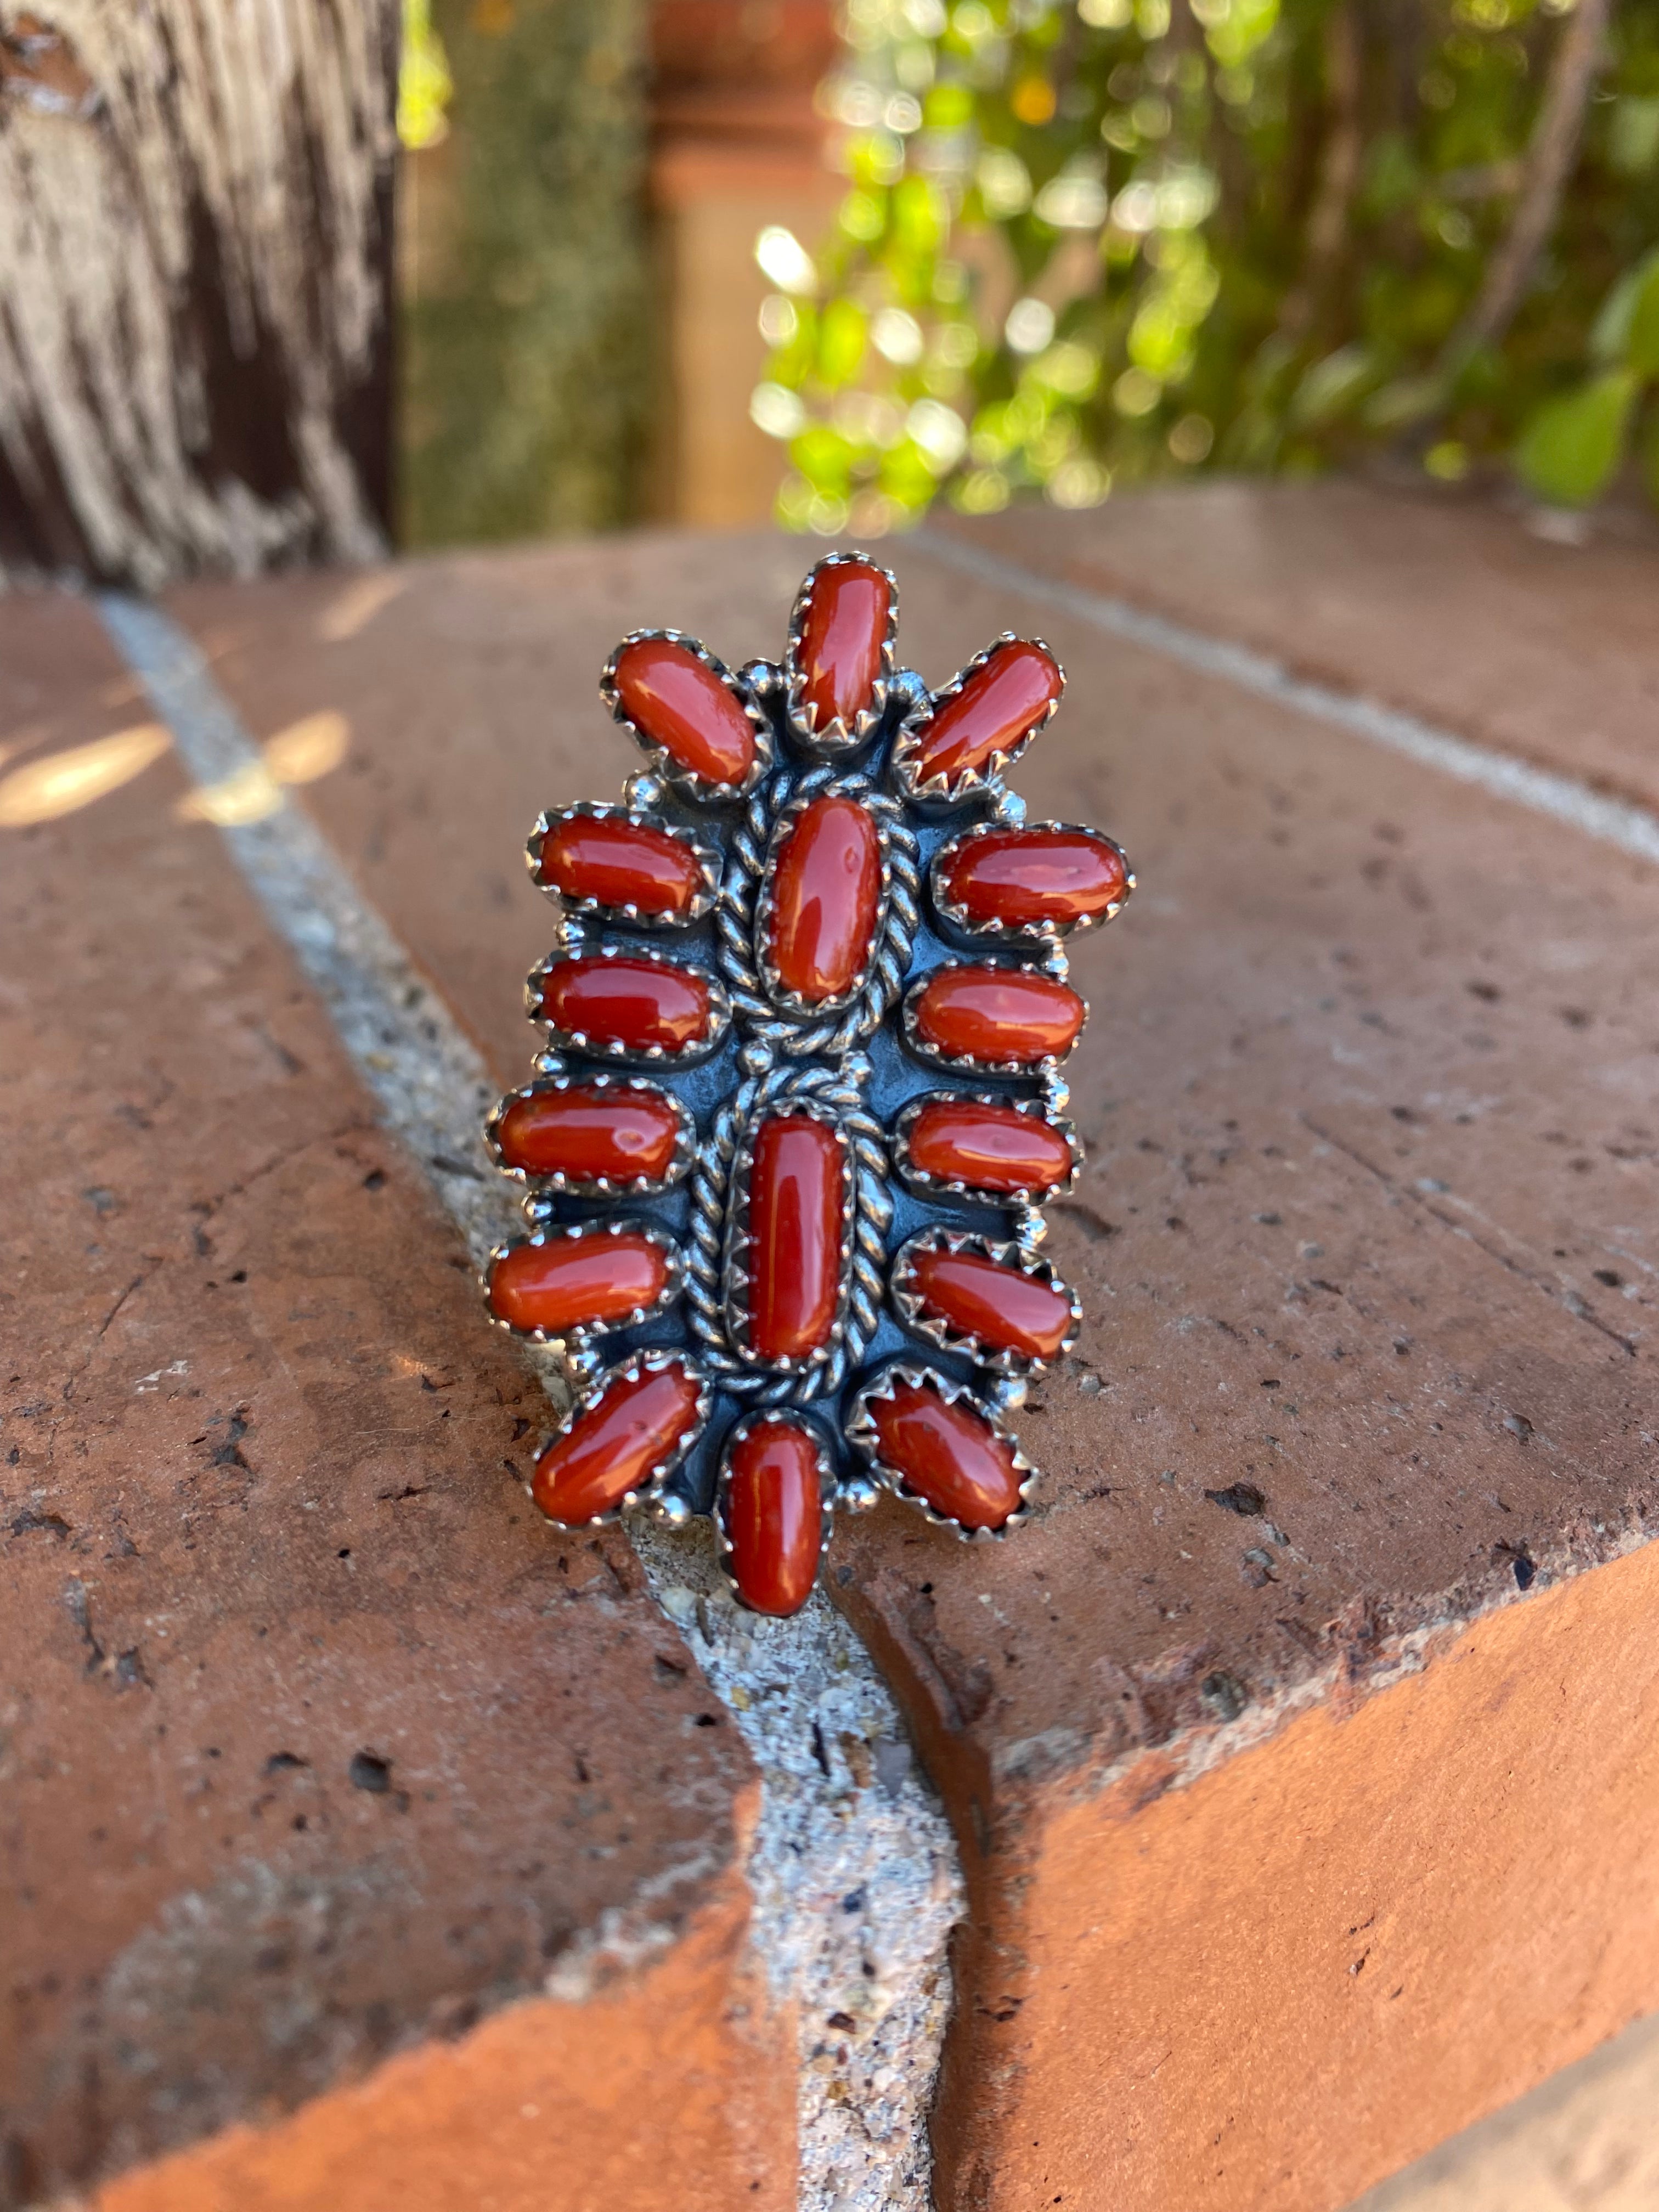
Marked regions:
[947,478,1659,808]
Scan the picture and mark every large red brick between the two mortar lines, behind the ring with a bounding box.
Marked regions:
[166,493,1659,2212]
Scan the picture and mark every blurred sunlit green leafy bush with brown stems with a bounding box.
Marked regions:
[752,0,1659,533]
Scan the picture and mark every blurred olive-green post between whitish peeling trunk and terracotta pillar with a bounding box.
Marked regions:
[398,0,650,544]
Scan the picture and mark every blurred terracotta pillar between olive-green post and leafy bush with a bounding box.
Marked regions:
[646,0,843,527]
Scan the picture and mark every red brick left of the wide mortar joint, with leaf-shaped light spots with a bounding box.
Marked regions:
[0,600,794,2212]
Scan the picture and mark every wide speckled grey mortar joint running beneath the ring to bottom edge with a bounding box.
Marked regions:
[95,593,964,2212]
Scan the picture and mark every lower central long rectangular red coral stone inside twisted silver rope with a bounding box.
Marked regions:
[748,1113,840,1361]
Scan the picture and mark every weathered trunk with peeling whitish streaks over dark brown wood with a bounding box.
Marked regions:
[0,0,398,589]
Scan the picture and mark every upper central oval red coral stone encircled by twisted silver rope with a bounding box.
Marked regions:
[768,799,881,1007]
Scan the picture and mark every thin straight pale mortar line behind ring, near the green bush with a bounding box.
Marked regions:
[909,529,1659,862]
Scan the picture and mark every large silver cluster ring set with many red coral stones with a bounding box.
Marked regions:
[484,553,1135,1615]
